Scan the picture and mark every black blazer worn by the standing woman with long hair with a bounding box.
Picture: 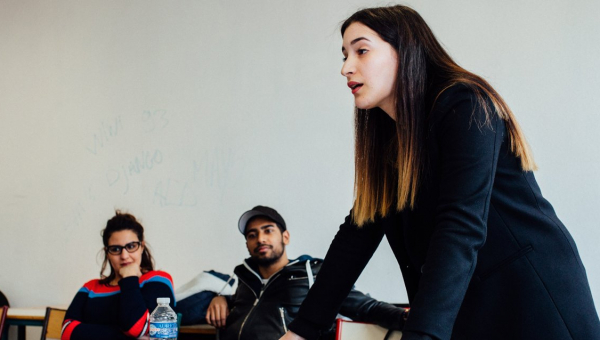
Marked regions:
[290,85,600,340]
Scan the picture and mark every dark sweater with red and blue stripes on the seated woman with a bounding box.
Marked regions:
[61,271,175,340]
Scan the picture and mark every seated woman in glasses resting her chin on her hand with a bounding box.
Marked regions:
[61,210,175,340]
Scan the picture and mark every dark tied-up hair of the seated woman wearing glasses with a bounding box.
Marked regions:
[100,210,154,285]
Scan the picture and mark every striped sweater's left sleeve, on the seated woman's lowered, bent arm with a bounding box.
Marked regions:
[60,289,131,340]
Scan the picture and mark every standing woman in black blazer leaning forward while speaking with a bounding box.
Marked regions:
[282,6,600,340]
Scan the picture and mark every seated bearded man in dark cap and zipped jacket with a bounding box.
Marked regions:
[206,206,406,340]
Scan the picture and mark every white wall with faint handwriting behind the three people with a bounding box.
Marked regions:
[0,0,600,338]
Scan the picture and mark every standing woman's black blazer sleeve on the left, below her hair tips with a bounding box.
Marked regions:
[289,215,383,340]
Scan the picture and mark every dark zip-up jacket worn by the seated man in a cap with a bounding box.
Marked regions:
[219,255,403,340]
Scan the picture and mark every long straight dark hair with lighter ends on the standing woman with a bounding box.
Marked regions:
[341,5,536,226]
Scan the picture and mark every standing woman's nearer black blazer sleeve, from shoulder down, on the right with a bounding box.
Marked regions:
[403,85,505,340]
